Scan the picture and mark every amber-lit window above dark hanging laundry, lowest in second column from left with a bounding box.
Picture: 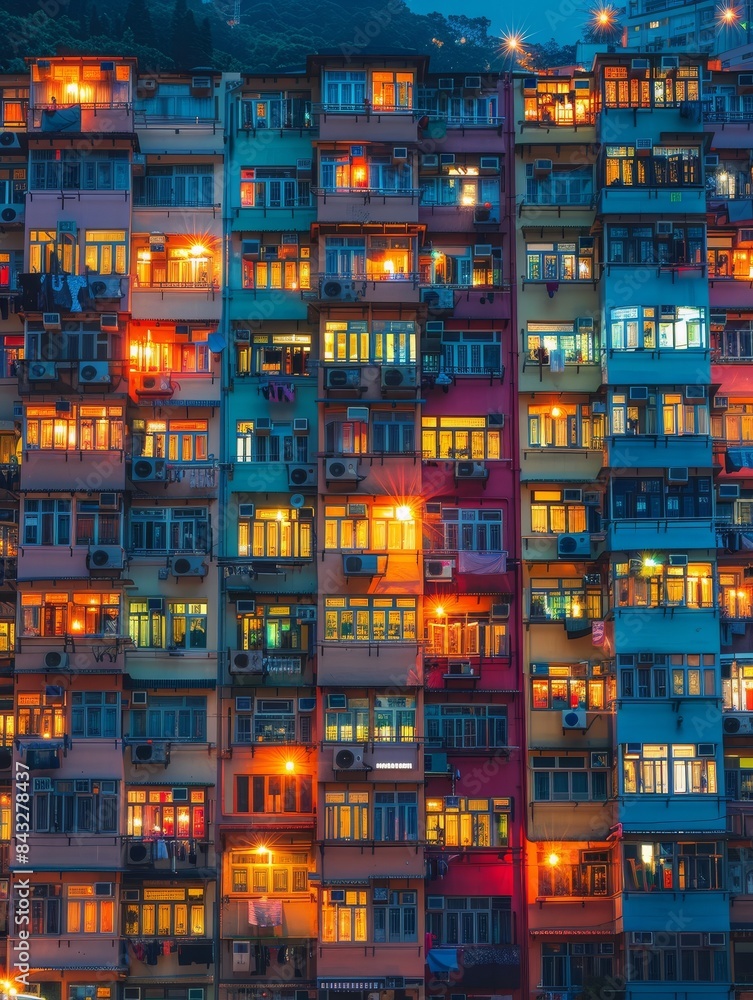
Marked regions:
[123,886,207,938]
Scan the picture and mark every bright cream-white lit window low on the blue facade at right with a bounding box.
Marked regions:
[622,743,717,795]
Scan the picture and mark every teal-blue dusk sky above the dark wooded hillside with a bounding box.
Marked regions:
[408,0,588,43]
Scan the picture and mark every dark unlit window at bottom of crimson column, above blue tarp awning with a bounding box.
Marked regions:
[426,896,513,946]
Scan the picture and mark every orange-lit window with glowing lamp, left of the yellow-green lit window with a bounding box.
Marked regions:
[21,591,120,638]
